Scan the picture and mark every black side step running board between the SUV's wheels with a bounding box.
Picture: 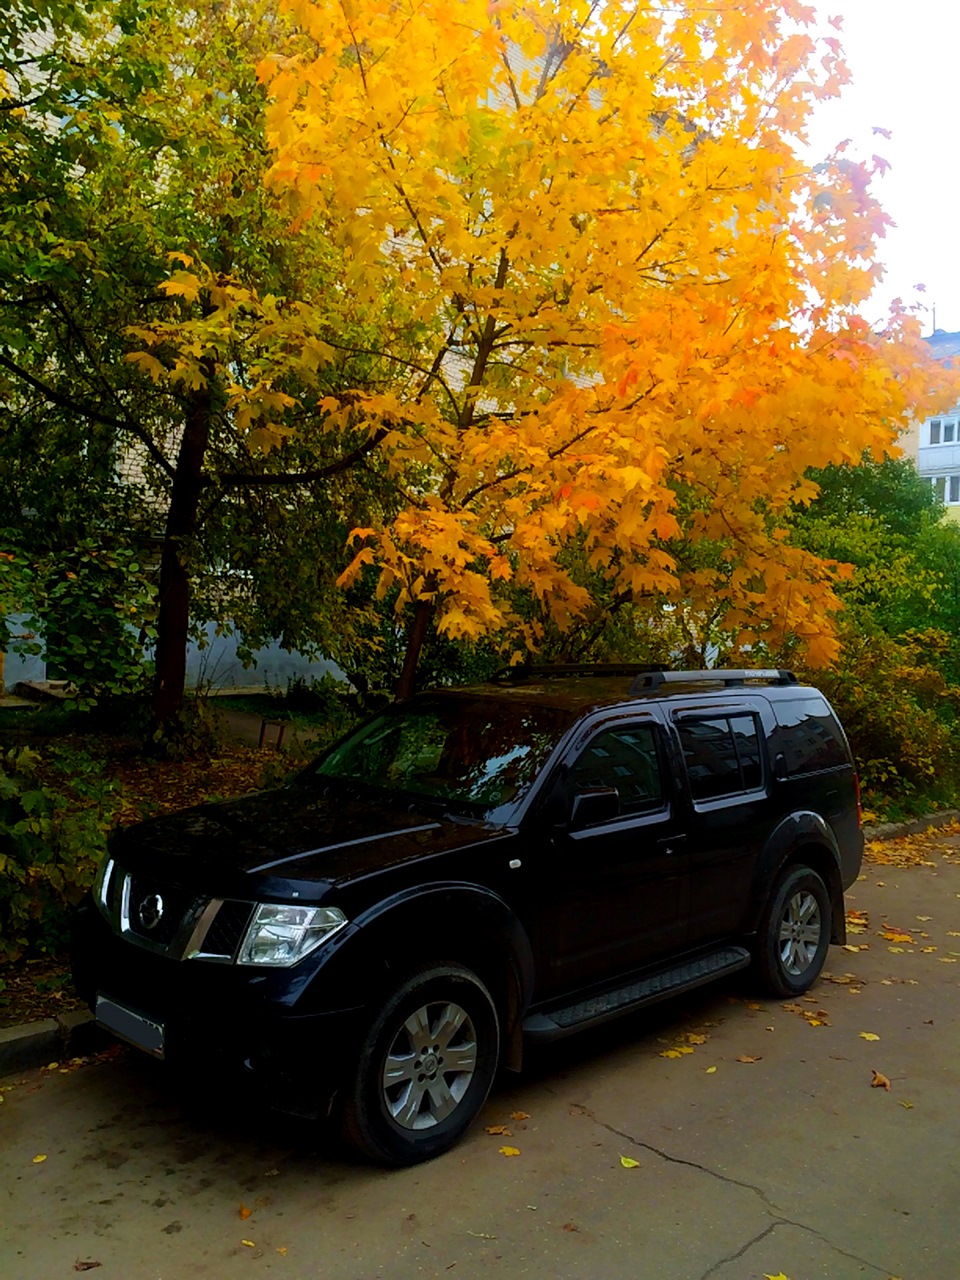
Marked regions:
[524,947,750,1041]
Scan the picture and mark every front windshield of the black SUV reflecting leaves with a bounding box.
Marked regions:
[304,696,571,815]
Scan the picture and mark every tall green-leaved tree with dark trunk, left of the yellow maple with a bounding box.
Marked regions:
[0,0,392,726]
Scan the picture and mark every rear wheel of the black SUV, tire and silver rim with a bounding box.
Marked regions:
[754,867,831,996]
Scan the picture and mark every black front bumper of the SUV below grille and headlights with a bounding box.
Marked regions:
[72,902,369,1117]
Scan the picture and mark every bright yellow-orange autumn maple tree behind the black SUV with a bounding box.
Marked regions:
[249,0,956,691]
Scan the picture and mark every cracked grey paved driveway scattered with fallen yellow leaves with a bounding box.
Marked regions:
[0,842,960,1280]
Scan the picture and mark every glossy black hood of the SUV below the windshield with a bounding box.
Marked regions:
[110,785,504,884]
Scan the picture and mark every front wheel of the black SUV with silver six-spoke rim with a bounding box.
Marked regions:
[340,964,500,1167]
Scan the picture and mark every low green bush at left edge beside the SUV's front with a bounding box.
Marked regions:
[0,748,115,960]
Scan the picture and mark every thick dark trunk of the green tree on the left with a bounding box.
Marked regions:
[154,367,214,730]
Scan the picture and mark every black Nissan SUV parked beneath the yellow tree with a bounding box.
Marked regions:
[74,667,863,1165]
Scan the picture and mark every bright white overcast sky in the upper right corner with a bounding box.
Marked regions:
[810,0,960,333]
